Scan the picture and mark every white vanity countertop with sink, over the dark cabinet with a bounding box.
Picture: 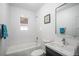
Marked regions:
[45,42,75,56]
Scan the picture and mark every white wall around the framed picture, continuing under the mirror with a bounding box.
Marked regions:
[37,3,79,46]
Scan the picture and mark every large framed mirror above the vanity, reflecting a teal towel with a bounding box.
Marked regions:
[55,3,79,36]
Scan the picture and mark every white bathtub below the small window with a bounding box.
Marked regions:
[6,42,41,56]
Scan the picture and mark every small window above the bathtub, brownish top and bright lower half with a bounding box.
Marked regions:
[20,17,28,30]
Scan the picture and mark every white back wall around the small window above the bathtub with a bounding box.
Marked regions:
[8,6,36,47]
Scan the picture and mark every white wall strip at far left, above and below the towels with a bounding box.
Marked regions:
[0,3,8,55]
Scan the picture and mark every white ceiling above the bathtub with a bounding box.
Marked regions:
[10,3,45,12]
